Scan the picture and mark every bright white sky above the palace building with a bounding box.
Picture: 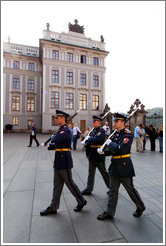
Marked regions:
[1,1,165,113]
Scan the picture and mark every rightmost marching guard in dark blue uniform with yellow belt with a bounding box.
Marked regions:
[97,113,145,220]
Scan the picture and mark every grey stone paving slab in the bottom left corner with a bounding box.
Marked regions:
[3,191,33,243]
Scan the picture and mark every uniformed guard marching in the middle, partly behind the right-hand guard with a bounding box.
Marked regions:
[82,116,109,195]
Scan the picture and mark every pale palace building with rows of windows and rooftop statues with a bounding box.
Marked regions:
[3,20,108,133]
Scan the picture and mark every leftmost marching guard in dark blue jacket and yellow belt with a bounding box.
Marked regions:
[40,110,87,215]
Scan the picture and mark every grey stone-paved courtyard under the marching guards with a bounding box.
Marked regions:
[1,133,164,245]
